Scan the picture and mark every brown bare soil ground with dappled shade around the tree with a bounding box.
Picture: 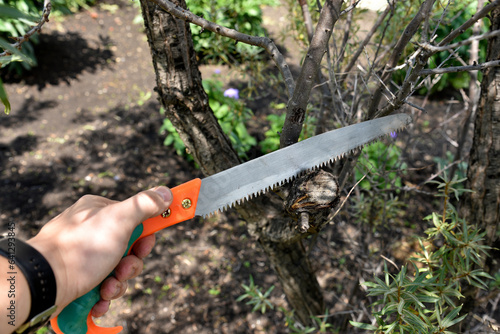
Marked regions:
[0,0,498,333]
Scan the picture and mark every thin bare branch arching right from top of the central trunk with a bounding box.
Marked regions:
[151,0,295,96]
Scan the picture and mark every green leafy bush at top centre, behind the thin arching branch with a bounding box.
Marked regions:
[186,0,279,64]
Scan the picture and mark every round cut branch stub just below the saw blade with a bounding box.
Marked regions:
[284,170,339,233]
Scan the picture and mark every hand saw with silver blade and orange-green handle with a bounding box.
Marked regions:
[51,114,411,334]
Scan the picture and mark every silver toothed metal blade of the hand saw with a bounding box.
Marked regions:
[196,114,411,216]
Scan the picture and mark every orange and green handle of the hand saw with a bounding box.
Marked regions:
[50,179,201,334]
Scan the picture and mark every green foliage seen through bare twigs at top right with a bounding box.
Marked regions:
[386,0,488,94]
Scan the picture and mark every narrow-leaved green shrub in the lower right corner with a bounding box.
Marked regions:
[351,179,492,333]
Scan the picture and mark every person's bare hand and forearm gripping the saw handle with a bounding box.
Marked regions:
[0,187,172,334]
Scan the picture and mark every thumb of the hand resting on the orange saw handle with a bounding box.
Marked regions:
[110,186,173,229]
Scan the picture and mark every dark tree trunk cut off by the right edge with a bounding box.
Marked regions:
[466,8,500,274]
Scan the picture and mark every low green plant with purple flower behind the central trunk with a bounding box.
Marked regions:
[160,80,257,158]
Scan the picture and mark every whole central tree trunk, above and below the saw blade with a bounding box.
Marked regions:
[141,0,324,325]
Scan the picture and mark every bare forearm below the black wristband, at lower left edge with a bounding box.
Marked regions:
[0,256,31,333]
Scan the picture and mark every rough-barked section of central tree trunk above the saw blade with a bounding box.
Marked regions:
[141,1,240,175]
